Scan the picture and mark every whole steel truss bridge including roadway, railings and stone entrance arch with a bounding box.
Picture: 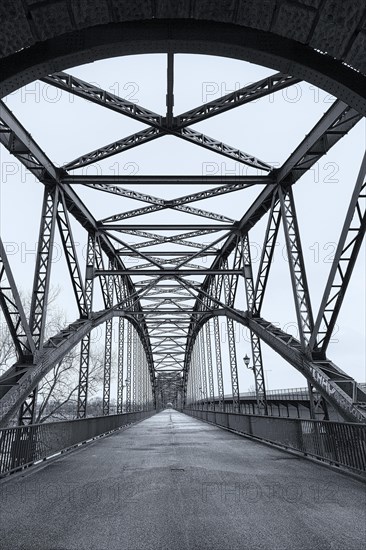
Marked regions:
[0,4,366,550]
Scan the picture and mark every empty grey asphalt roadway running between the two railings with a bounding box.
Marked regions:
[0,410,366,550]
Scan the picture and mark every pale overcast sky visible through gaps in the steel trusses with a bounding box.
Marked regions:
[0,55,366,393]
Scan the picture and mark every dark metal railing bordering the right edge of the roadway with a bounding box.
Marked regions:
[183,409,366,475]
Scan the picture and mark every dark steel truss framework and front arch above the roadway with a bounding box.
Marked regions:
[0,2,366,436]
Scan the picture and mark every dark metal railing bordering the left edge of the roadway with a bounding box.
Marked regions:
[0,410,155,476]
